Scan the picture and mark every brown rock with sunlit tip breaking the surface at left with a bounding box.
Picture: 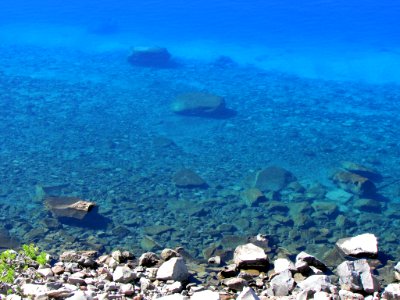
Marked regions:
[45,197,96,220]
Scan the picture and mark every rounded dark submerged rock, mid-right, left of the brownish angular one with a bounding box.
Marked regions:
[247,166,296,192]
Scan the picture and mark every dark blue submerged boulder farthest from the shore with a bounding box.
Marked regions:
[128,47,171,68]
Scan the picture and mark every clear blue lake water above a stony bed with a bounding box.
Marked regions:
[0,0,400,260]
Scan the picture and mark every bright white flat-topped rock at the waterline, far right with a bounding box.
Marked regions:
[336,233,378,256]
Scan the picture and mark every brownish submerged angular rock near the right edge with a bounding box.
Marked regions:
[333,171,376,197]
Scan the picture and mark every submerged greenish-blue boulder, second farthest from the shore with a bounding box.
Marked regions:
[171,92,226,116]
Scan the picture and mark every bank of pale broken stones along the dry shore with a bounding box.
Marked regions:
[3,233,400,300]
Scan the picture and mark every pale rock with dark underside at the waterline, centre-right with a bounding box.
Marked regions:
[233,243,268,270]
